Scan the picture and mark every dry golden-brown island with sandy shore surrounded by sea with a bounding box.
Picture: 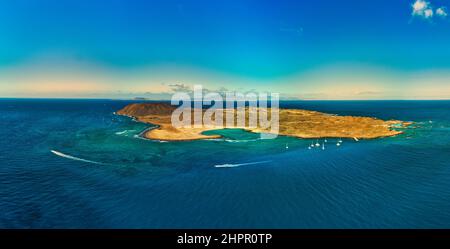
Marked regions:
[117,102,411,141]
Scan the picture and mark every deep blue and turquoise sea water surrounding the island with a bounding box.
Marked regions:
[0,99,450,228]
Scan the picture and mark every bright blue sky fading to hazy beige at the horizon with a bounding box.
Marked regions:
[0,0,450,99]
